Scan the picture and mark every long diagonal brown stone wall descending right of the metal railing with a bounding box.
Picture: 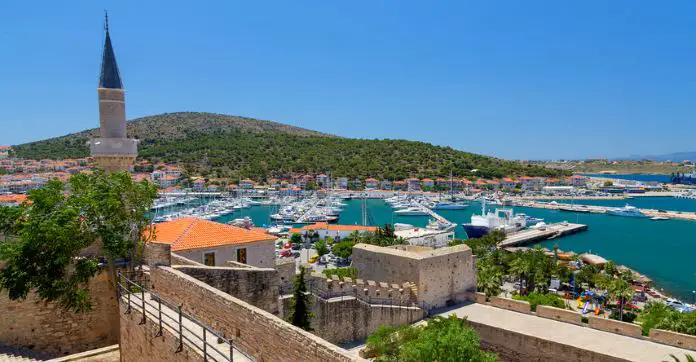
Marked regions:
[151,266,361,362]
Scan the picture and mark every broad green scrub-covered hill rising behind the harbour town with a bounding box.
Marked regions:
[14,113,569,180]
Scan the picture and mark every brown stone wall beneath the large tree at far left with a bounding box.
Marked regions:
[0,271,119,357]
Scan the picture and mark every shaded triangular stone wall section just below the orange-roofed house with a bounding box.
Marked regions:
[173,266,280,314]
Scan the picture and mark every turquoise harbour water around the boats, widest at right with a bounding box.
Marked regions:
[196,198,696,301]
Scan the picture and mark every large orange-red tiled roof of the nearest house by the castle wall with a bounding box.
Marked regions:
[152,217,277,251]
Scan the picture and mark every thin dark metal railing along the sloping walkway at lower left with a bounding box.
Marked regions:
[117,273,254,362]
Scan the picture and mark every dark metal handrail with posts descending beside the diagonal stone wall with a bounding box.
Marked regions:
[116,272,254,362]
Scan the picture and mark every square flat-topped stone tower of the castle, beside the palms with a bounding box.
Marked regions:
[353,244,476,308]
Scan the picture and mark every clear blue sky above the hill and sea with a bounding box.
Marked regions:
[0,0,696,159]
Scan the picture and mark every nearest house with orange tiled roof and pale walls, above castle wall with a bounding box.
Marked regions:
[152,217,278,268]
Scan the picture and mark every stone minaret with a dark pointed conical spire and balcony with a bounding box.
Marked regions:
[90,15,138,172]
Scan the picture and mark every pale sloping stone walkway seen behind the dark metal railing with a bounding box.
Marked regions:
[125,293,253,362]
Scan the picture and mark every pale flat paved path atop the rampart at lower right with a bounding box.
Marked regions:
[440,303,696,362]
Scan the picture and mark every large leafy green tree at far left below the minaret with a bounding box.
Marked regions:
[0,171,157,312]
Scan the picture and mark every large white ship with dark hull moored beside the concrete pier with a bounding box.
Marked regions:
[462,200,527,238]
